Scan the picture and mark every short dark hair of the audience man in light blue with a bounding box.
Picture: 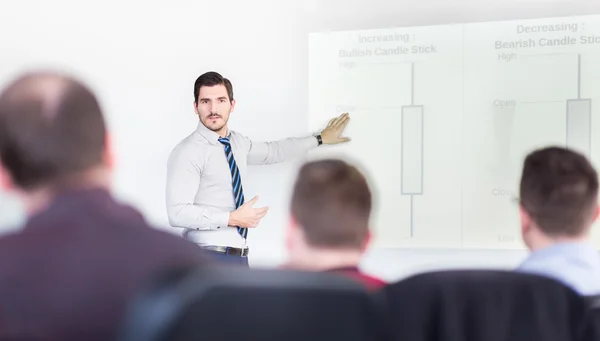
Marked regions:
[519,146,598,237]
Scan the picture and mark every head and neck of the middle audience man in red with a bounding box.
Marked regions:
[287,159,372,270]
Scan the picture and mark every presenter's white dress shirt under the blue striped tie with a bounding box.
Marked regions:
[166,122,318,248]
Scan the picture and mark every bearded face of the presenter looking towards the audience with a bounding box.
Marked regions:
[194,85,235,136]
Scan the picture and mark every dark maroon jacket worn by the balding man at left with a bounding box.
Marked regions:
[0,190,206,341]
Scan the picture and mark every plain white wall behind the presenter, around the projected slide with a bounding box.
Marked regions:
[0,0,600,280]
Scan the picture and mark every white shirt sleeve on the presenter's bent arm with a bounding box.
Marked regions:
[166,143,229,230]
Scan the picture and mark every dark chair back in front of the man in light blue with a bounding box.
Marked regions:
[379,270,586,341]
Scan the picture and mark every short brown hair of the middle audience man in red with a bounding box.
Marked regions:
[291,159,372,248]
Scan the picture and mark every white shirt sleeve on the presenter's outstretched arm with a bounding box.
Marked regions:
[245,136,319,165]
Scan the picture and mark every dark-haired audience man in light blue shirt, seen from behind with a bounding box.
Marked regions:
[518,147,600,296]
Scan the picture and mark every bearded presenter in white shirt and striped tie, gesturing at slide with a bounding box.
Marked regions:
[166,72,349,266]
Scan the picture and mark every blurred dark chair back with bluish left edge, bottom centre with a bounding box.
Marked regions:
[121,267,382,341]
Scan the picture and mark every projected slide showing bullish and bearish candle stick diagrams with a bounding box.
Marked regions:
[309,16,600,249]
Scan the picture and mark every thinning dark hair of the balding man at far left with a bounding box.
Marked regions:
[0,73,106,190]
